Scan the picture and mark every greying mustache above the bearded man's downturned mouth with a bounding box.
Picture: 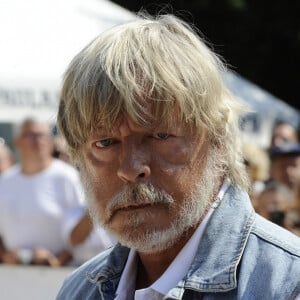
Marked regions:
[106,184,174,219]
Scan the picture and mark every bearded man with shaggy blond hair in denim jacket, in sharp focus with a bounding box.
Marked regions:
[57,15,300,300]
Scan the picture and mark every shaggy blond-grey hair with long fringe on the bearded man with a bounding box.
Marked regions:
[57,15,248,188]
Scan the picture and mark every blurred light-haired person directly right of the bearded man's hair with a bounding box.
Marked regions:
[242,142,270,207]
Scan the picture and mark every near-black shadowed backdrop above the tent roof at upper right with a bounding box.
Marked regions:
[115,0,300,108]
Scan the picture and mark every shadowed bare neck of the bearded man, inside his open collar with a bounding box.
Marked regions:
[136,224,198,289]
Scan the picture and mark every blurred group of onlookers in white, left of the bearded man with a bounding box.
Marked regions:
[0,118,114,267]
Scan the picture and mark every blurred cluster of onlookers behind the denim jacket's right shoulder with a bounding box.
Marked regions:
[243,121,300,236]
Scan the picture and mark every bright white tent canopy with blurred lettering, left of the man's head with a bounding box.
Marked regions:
[0,0,134,123]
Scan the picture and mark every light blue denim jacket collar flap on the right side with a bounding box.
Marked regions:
[168,186,255,297]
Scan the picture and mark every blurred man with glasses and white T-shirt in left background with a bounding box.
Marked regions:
[0,119,83,266]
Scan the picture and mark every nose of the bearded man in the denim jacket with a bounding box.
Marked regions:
[117,143,151,183]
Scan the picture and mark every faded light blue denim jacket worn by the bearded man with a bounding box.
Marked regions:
[57,186,300,300]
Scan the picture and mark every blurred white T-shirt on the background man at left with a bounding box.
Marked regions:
[0,160,83,254]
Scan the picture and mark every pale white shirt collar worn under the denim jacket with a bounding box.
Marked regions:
[115,180,229,300]
